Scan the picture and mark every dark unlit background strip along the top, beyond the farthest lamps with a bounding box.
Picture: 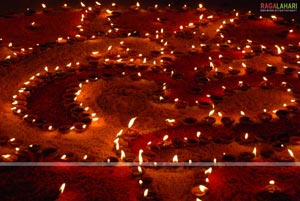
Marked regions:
[0,0,300,20]
